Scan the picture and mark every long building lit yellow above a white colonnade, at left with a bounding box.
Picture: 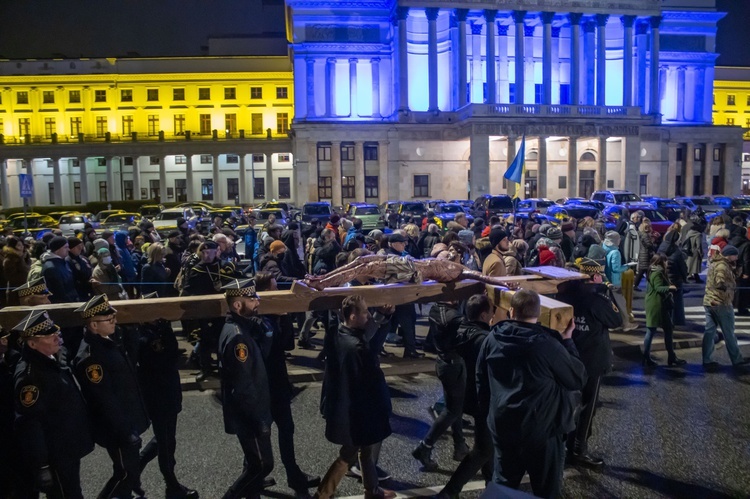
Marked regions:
[0,56,296,208]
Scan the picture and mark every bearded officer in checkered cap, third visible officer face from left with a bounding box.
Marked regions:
[219,279,273,499]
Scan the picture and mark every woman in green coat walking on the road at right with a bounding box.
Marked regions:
[643,254,686,367]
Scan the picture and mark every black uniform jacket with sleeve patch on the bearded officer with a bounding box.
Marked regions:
[219,312,273,435]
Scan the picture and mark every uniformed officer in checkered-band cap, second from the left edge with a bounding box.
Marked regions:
[73,295,149,498]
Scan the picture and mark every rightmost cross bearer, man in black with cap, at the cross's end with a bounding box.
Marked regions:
[557,258,622,468]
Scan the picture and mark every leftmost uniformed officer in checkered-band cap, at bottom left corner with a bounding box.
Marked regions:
[14,310,94,498]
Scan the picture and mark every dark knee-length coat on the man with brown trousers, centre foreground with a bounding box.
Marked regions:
[321,324,391,446]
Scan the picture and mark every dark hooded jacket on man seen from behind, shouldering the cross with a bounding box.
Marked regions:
[476,320,586,444]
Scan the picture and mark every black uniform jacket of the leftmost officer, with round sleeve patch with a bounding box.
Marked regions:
[14,348,94,470]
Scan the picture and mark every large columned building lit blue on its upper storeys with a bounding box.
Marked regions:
[287,0,742,205]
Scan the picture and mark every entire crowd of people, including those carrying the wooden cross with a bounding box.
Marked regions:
[0,204,750,498]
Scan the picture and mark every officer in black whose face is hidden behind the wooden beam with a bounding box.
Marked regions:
[138,292,198,499]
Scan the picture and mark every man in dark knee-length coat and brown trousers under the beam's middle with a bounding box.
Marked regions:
[316,295,395,499]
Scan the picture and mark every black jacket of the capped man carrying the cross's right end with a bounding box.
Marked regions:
[557,281,622,377]
